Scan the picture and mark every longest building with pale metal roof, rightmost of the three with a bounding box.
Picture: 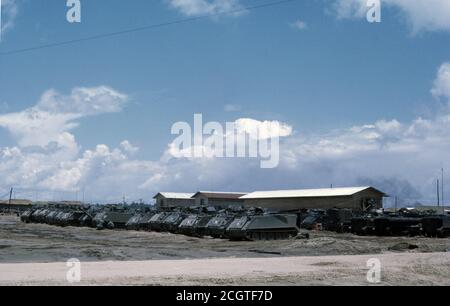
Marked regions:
[240,187,387,211]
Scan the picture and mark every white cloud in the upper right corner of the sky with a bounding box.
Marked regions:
[333,0,450,33]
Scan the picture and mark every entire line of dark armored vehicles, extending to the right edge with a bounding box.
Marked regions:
[21,206,450,240]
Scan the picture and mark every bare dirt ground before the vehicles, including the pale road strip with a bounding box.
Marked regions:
[0,216,450,285]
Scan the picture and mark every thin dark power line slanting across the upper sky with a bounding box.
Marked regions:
[0,0,297,56]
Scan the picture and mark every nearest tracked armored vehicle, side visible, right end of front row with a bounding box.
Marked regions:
[227,214,299,240]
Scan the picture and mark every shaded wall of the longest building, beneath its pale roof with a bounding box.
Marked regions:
[245,191,383,210]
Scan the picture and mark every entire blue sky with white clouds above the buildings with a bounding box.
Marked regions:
[0,0,450,205]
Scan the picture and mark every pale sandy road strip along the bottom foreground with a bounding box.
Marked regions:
[0,253,450,286]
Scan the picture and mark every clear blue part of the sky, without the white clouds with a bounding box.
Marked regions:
[0,0,450,206]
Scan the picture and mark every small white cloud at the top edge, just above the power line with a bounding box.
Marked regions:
[167,0,242,16]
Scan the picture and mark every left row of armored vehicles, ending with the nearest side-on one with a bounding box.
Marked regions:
[21,207,299,240]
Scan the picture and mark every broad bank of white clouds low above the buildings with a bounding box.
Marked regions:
[0,64,450,204]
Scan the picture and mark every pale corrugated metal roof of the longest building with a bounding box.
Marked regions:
[241,187,382,200]
